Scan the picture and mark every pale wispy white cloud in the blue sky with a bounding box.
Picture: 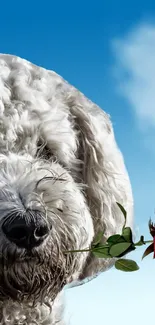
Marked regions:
[112,24,155,128]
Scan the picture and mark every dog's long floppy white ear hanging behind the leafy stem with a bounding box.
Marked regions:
[67,94,133,280]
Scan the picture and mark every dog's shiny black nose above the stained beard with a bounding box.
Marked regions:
[2,210,49,250]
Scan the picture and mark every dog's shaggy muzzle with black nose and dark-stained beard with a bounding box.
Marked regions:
[0,154,94,301]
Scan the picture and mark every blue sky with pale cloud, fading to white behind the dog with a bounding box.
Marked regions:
[0,0,155,325]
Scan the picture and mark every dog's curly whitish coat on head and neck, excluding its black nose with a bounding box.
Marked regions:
[0,54,133,325]
